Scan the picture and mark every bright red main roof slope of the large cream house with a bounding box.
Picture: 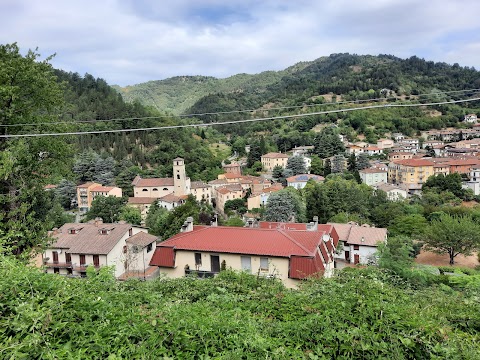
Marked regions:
[153,226,323,258]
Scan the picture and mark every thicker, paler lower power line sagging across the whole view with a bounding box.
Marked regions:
[0,98,480,138]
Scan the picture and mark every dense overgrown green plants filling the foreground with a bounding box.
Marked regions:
[0,258,480,359]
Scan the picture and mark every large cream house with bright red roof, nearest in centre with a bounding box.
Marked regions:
[150,218,338,287]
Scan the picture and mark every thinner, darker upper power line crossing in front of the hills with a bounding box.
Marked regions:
[0,89,480,127]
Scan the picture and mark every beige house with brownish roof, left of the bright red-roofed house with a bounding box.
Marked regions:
[43,219,157,278]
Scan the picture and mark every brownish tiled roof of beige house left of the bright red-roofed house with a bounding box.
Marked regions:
[50,223,132,255]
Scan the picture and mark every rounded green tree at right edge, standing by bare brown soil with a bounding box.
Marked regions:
[423,214,480,265]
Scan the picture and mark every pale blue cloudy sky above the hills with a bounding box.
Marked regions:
[0,0,480,86]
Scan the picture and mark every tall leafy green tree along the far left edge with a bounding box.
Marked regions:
[0,44,71,256]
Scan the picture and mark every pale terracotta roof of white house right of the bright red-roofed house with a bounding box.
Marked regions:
[329,223,387,246]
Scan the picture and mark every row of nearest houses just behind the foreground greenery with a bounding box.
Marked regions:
[43,218,387,288]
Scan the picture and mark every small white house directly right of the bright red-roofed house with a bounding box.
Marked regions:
[329,222,387,268]
